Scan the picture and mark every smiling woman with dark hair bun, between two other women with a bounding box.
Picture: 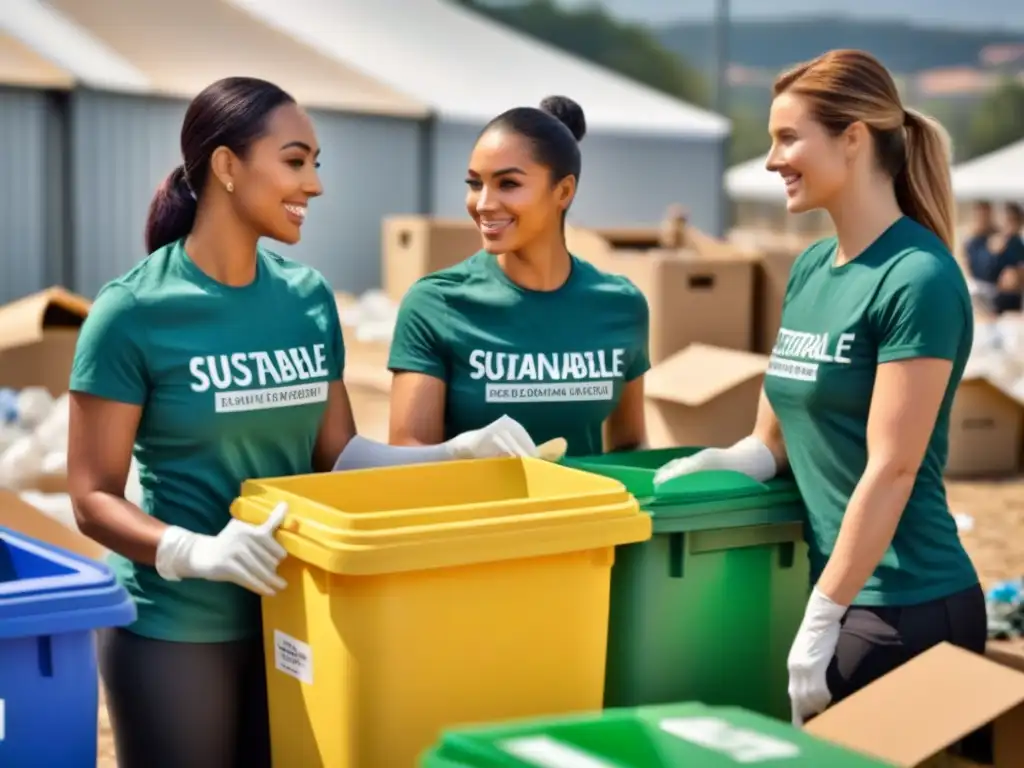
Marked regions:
[389,96,650,456]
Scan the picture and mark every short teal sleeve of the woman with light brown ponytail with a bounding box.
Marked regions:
[871,251,971,362]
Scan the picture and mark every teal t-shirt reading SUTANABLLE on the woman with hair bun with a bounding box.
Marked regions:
[388,251,650,456]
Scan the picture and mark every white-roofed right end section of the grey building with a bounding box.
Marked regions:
[228,0,729,231]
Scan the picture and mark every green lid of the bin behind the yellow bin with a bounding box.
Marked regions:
[562,446,803,526]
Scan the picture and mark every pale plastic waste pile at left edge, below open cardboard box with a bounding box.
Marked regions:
[0,387,141,506]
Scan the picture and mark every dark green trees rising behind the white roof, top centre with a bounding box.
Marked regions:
[457,0,709,105]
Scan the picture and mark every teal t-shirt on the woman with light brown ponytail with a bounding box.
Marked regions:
[765,217,978,605]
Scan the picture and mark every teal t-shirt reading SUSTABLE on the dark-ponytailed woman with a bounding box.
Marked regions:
[71,242,344,642]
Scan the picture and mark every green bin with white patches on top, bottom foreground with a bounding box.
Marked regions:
[420,703,891,768]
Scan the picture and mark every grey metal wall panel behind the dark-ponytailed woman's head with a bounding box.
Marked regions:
[73,91,422,296]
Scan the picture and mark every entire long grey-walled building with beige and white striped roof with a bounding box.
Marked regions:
[0,0,729,295]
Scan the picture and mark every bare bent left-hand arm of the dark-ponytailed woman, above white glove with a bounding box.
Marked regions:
[68,392,167,565]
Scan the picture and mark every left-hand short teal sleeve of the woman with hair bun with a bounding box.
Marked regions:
[388,281,449,381]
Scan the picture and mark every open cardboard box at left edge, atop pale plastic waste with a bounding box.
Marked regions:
[0,288,91,397]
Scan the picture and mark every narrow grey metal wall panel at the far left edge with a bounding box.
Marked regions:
[0,87,54,303]
